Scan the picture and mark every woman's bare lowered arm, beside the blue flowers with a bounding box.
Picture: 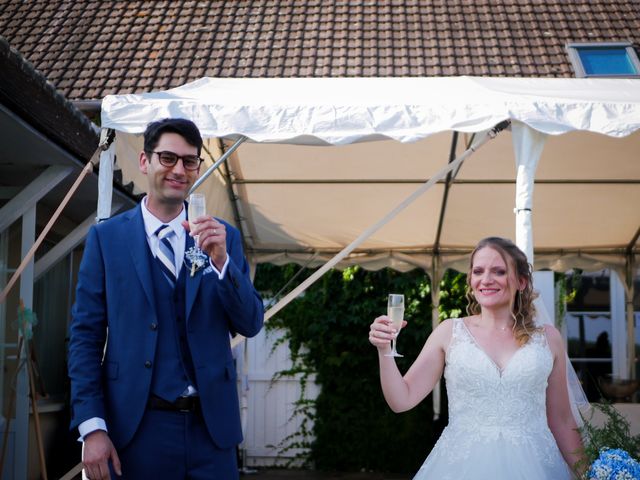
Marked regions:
[545,325,584,469]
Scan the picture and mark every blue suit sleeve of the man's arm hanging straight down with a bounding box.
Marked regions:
[69,226,107,428]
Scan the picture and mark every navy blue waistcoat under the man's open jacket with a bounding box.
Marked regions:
[149,252,197,401]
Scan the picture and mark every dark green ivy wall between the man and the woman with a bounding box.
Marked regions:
[255,265,466,473]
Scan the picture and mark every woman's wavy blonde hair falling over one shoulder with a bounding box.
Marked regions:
[467,237,540,345]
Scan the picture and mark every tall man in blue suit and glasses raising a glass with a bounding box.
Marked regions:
[69,119,263,480]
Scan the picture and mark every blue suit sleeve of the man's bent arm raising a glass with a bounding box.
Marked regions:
[219,222,264,337]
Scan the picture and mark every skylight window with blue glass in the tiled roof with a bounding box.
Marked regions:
[567,42,640,78]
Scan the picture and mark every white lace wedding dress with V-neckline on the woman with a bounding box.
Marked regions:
[414,319,571,480]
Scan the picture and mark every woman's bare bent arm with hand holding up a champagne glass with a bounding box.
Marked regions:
[369,315,452,412]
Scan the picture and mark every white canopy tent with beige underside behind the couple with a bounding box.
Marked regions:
[101,77,640,380]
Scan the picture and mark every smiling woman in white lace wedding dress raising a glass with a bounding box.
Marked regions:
[369,237,583,480]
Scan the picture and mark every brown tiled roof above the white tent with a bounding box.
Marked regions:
[0,0,640,100]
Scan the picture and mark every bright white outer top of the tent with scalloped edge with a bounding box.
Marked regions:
[102,77,640,145]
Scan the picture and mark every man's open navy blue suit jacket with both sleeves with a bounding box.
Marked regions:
[69,205,263,449]
